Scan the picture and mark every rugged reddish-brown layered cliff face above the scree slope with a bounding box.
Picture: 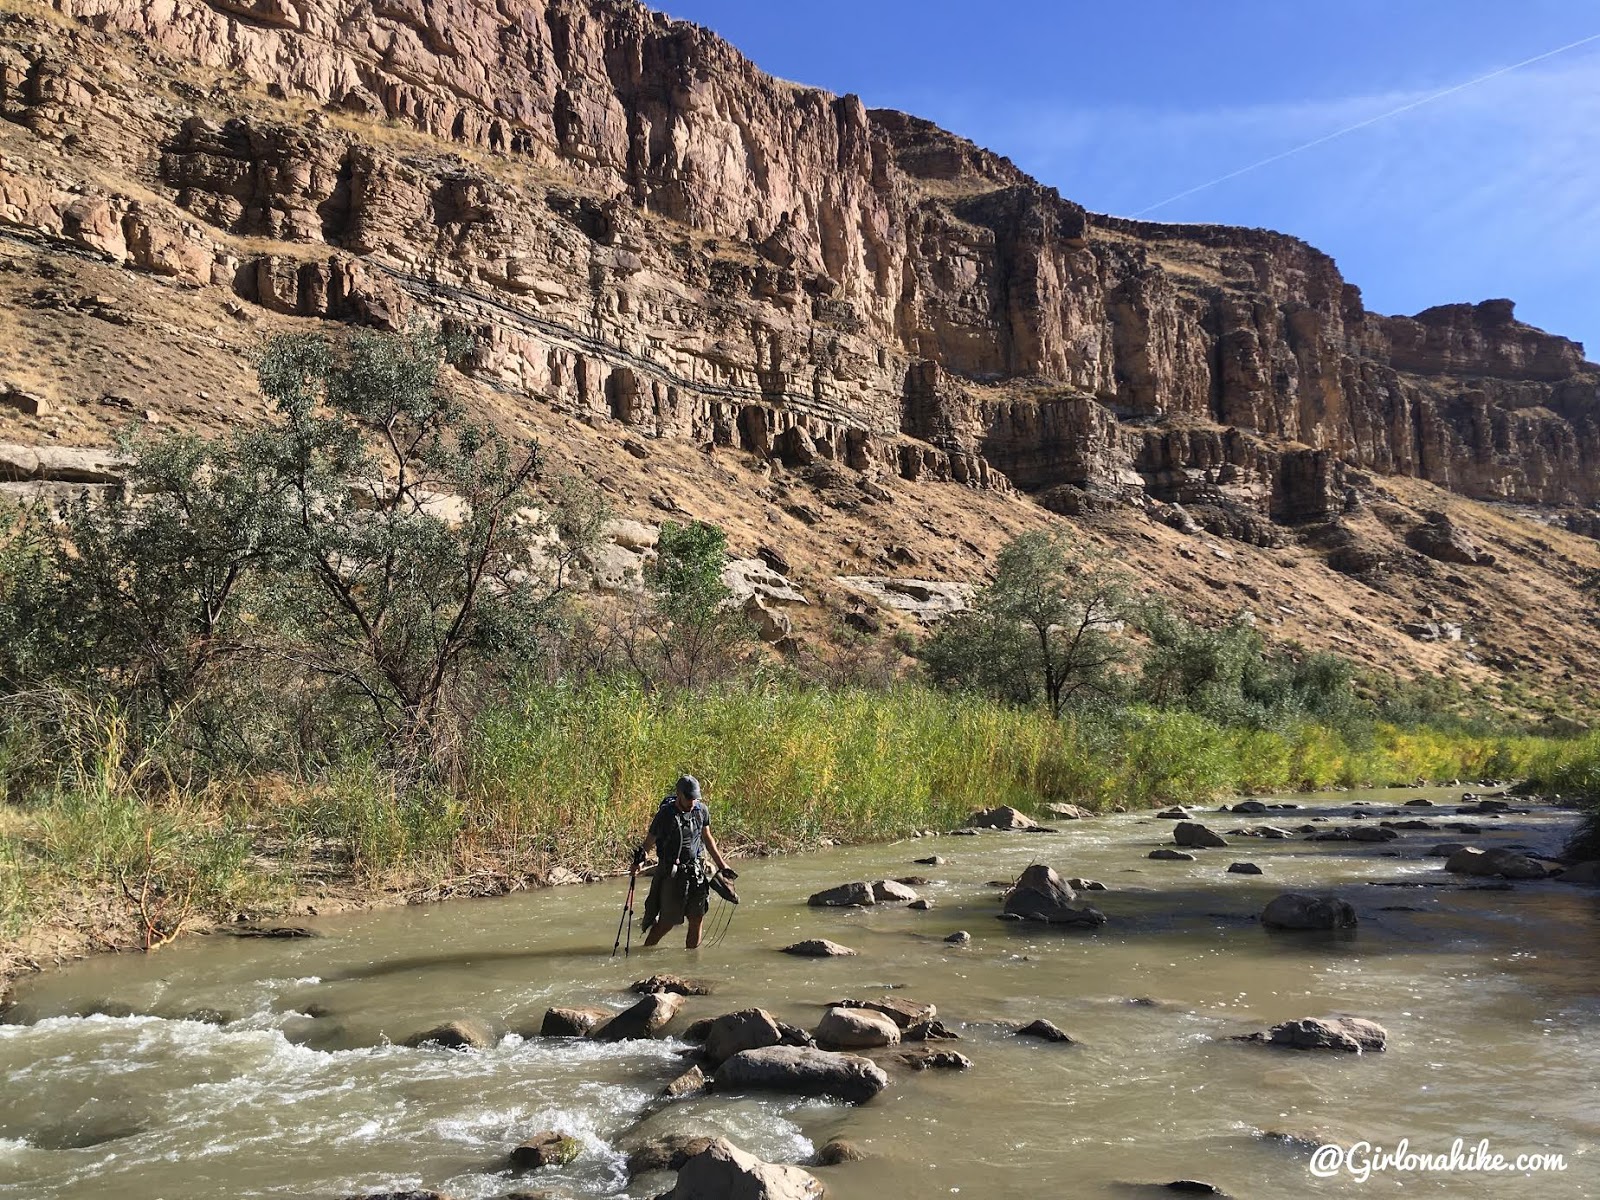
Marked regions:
[0,0,1600,541]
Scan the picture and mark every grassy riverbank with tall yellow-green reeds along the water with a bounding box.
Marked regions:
[0,686,1600,1004]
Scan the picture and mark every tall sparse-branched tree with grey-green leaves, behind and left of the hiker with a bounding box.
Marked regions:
[251,328,579,765]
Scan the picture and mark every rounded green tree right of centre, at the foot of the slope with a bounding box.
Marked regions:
[923,530,1130,717]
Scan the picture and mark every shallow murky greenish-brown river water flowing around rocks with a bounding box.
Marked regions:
[0,790,1600,1200]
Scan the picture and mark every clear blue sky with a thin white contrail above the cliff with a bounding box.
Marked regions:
[658,0,1600,360]
